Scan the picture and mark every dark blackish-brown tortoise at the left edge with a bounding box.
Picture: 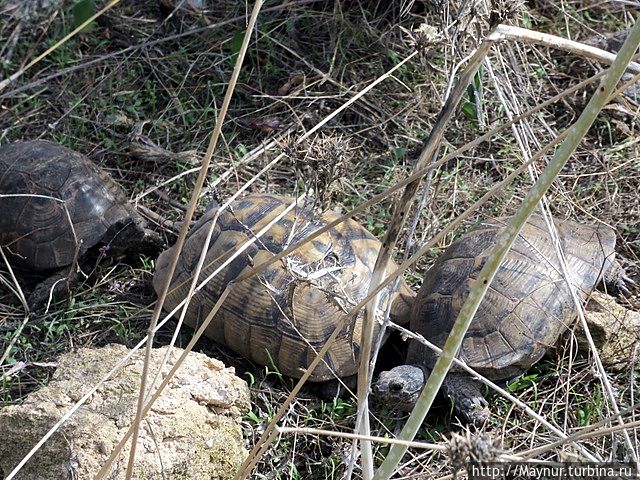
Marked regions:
[0,140,160,310]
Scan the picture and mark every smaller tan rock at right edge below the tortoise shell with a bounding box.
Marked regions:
[576,292,640,370]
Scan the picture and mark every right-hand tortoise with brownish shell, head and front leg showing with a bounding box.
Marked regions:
[374,215,621,423]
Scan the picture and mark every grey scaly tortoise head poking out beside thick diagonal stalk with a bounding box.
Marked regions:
[373,365,429,412]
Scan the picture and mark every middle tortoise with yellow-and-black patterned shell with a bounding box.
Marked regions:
[153,195,415,384]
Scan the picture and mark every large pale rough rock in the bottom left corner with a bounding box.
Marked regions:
[0,345,249,480]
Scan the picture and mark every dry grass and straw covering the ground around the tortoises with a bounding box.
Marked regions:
[0,0,640,478]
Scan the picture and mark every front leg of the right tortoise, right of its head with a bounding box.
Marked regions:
[442,373,489,425]
